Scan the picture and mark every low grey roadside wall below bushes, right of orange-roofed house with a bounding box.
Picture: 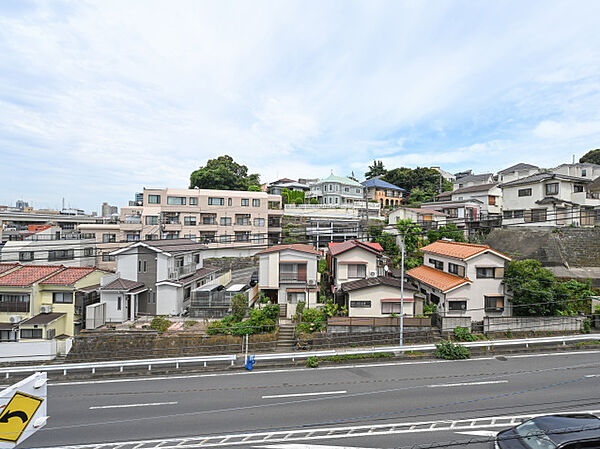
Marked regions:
[483,316,585,334]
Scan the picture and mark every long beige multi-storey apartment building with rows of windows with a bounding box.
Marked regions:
[79,188,283,270]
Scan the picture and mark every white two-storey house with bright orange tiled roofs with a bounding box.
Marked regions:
[406,240,511,321]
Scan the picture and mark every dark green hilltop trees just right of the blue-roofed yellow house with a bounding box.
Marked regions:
[383,167,452,203]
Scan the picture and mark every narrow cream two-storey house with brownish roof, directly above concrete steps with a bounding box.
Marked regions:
[257,243,321,318]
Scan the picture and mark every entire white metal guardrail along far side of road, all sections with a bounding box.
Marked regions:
[0,334,600,378]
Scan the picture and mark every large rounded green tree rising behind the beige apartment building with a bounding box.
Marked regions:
[190,155,260,190]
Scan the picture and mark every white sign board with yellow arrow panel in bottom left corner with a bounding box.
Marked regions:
[0,373,48,449]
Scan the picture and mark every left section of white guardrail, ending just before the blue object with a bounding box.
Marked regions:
[0,354,237,378]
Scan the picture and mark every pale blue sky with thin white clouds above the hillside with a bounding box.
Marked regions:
[0,0,600,211]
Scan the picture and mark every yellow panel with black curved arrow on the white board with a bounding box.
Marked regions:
[0,391,44,443]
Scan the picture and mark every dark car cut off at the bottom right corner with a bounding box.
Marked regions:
[496,413,600,449]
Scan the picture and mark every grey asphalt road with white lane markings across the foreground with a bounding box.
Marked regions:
[22,351,600,449]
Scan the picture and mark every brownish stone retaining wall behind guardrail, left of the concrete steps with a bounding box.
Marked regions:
[67,331,278,362]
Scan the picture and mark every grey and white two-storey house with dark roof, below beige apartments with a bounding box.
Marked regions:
[101,239,218,322]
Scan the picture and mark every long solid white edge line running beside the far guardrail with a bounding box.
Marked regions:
[42,351,600,387]
